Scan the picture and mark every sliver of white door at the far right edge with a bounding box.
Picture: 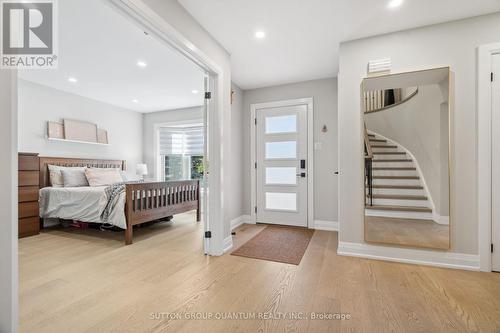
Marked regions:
[491,54,500,272]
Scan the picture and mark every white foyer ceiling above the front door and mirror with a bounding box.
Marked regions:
[178,0,500,89]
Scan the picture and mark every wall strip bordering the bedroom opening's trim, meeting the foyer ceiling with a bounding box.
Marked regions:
[142,0,233,241]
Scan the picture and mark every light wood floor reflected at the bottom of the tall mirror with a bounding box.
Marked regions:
[365,216,450,249]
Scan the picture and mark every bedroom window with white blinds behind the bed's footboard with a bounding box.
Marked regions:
[158,125,204,180]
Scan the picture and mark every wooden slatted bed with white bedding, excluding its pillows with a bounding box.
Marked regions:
[40,157,201,245]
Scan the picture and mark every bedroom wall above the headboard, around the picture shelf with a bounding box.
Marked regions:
[18,80,142,176]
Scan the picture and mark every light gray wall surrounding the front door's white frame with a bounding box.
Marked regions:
[243,78,338,222]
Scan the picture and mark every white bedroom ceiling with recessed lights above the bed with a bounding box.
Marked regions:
[20,0,204,112]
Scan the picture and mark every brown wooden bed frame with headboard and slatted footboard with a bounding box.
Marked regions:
[40,157,201,245]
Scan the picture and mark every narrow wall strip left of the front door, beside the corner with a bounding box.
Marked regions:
[229,83,246,227]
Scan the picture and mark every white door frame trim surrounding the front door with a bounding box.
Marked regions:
[250,97,314,229]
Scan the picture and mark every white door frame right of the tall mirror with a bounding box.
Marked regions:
[477,43,500,272]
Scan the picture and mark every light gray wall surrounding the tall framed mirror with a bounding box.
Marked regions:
[339,14,500,254]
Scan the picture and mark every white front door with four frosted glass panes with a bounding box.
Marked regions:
[256,105,308,227]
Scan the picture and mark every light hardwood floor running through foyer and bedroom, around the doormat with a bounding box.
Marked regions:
[19,214,500,333]
